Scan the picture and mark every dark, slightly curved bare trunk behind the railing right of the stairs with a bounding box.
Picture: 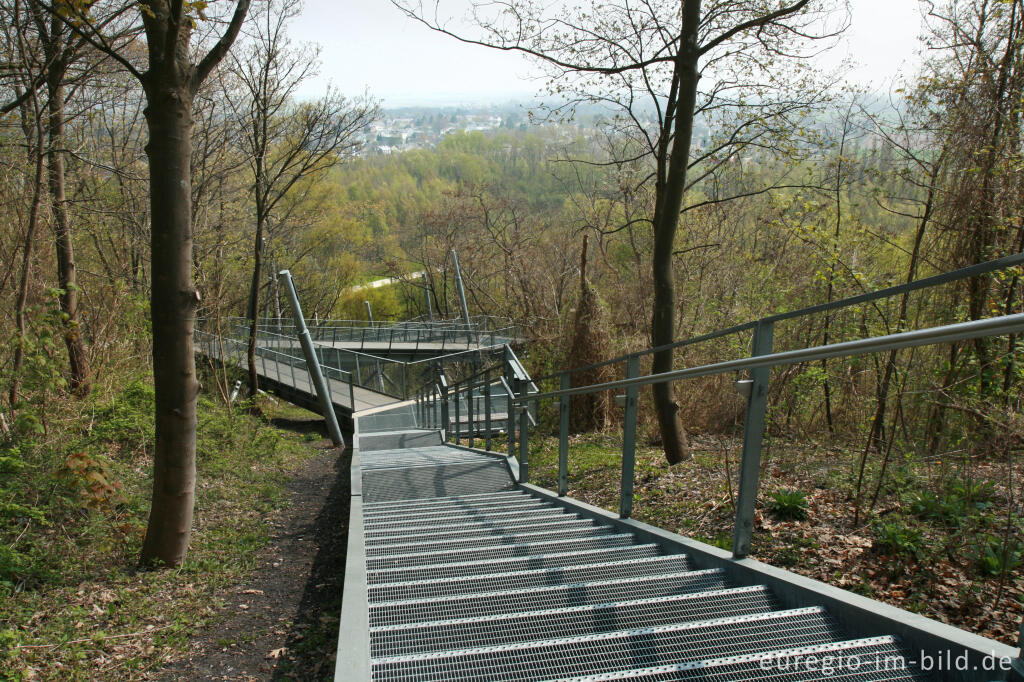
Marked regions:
[650,0,700,464]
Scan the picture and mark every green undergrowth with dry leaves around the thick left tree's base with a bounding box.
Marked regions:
[0,380,316,680]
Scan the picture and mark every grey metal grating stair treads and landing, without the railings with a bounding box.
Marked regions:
[346,430,941,682]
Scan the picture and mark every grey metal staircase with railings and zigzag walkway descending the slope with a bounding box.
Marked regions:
[198,259,1024,682]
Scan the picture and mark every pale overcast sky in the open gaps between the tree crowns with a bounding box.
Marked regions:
[292,0,921,106]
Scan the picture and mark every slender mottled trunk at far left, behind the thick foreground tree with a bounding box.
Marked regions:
[46,73,89,396]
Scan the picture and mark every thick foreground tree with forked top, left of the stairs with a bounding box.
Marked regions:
[34,0,250,566]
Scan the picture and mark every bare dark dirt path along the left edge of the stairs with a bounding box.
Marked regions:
[162,421,350,680]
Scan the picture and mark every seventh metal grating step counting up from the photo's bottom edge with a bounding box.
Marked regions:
[367,532,634,570]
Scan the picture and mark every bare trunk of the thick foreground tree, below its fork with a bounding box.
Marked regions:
[141,84,200,566]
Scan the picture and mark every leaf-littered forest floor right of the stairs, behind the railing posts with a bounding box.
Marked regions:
[530,434,1024,646]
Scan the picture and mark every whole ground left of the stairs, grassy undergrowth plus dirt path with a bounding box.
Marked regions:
[0,381,349,682]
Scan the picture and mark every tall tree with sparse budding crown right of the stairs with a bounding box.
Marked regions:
[392,0,846,463]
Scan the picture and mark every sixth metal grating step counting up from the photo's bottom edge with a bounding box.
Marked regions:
[367,545,660,585]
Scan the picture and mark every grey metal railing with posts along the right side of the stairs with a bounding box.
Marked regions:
[424,254,1024,558]
